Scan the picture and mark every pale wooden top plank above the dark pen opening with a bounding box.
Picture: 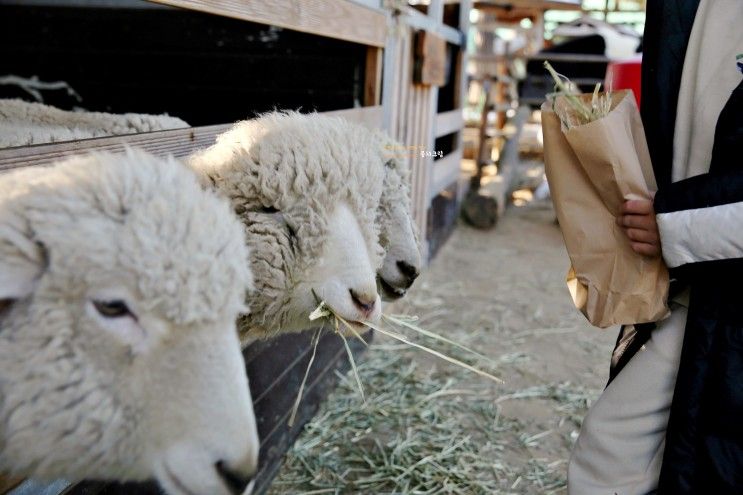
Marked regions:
[150,0,387,47]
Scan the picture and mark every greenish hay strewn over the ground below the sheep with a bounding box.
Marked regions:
[269,338,596,495]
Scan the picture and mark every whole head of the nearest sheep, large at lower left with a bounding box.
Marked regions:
[0,151,259,495]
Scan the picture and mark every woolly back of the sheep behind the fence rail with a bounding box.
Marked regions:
[0,99,189,148]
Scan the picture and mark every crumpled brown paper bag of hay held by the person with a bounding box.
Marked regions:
[542,91,668,328]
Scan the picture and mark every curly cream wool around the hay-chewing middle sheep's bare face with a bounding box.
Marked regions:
[190,112,384,338]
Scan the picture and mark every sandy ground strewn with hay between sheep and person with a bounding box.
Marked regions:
[269,202,616,495]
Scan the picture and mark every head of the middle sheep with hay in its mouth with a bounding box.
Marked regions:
[189,112,385,342]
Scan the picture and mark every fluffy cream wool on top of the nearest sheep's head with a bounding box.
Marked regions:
[0,149,252,324]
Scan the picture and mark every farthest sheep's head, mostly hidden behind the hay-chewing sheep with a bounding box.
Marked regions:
[377,131,422,301]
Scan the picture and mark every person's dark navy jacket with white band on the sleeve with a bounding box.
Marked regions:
[641,0,743,495]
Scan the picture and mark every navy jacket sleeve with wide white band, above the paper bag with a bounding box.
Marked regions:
[654,171,743,268]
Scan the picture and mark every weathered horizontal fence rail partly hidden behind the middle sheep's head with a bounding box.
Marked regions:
[0,106,382,172]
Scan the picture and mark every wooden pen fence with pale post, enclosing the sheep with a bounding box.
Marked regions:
[0,0,470,495]
